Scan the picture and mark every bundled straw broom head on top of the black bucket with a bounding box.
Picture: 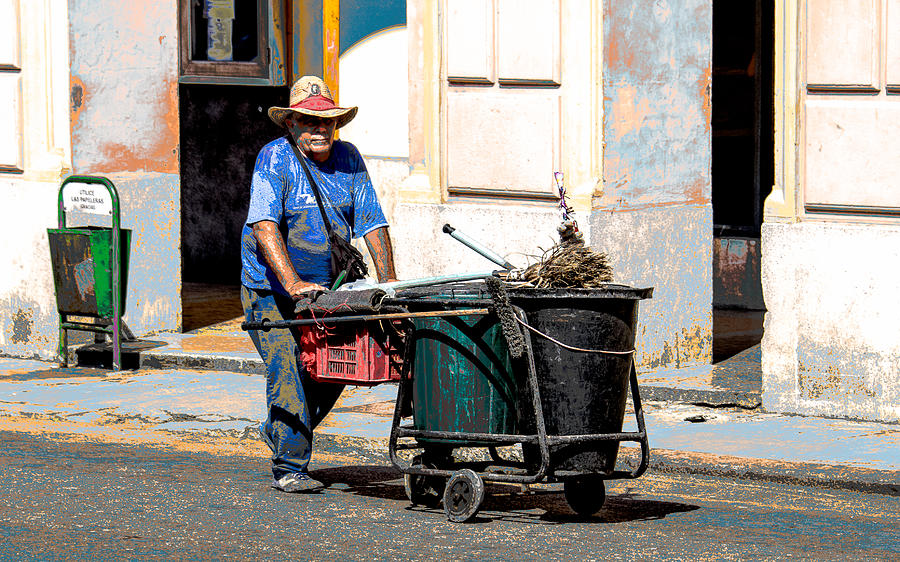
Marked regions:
[519,237,613,289]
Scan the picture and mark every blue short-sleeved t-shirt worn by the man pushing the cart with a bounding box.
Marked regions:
[241,137,387,295]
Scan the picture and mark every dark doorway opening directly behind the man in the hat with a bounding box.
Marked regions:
[179,84,289,332]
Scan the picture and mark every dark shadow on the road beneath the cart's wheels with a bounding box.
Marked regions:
[310,465,700,524]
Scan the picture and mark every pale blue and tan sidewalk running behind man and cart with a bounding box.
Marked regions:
[0,321,900,495]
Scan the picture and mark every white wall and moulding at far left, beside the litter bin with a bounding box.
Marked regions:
[0,0,71,359]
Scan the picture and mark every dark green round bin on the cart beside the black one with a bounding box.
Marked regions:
[404,284,524,447]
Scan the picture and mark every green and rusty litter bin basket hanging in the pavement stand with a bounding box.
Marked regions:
[47,226,131,318]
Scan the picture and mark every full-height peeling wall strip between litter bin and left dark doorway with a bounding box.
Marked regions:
[69,0,181,335]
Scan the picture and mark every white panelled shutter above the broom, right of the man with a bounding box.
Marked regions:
[441,0,563,199]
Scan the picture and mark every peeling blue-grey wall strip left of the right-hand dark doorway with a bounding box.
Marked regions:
[591,0,713,368]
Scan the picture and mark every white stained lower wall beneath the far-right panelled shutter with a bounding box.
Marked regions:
[762,222,900,421]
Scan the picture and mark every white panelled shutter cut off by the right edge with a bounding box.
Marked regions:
[800,0,900,216]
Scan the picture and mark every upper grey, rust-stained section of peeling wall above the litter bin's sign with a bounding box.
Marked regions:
[69,0,178,174]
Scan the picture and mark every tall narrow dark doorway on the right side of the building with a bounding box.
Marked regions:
[712,0,775,362]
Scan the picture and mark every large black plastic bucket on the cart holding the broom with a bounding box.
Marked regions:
[509,285,653,473]
